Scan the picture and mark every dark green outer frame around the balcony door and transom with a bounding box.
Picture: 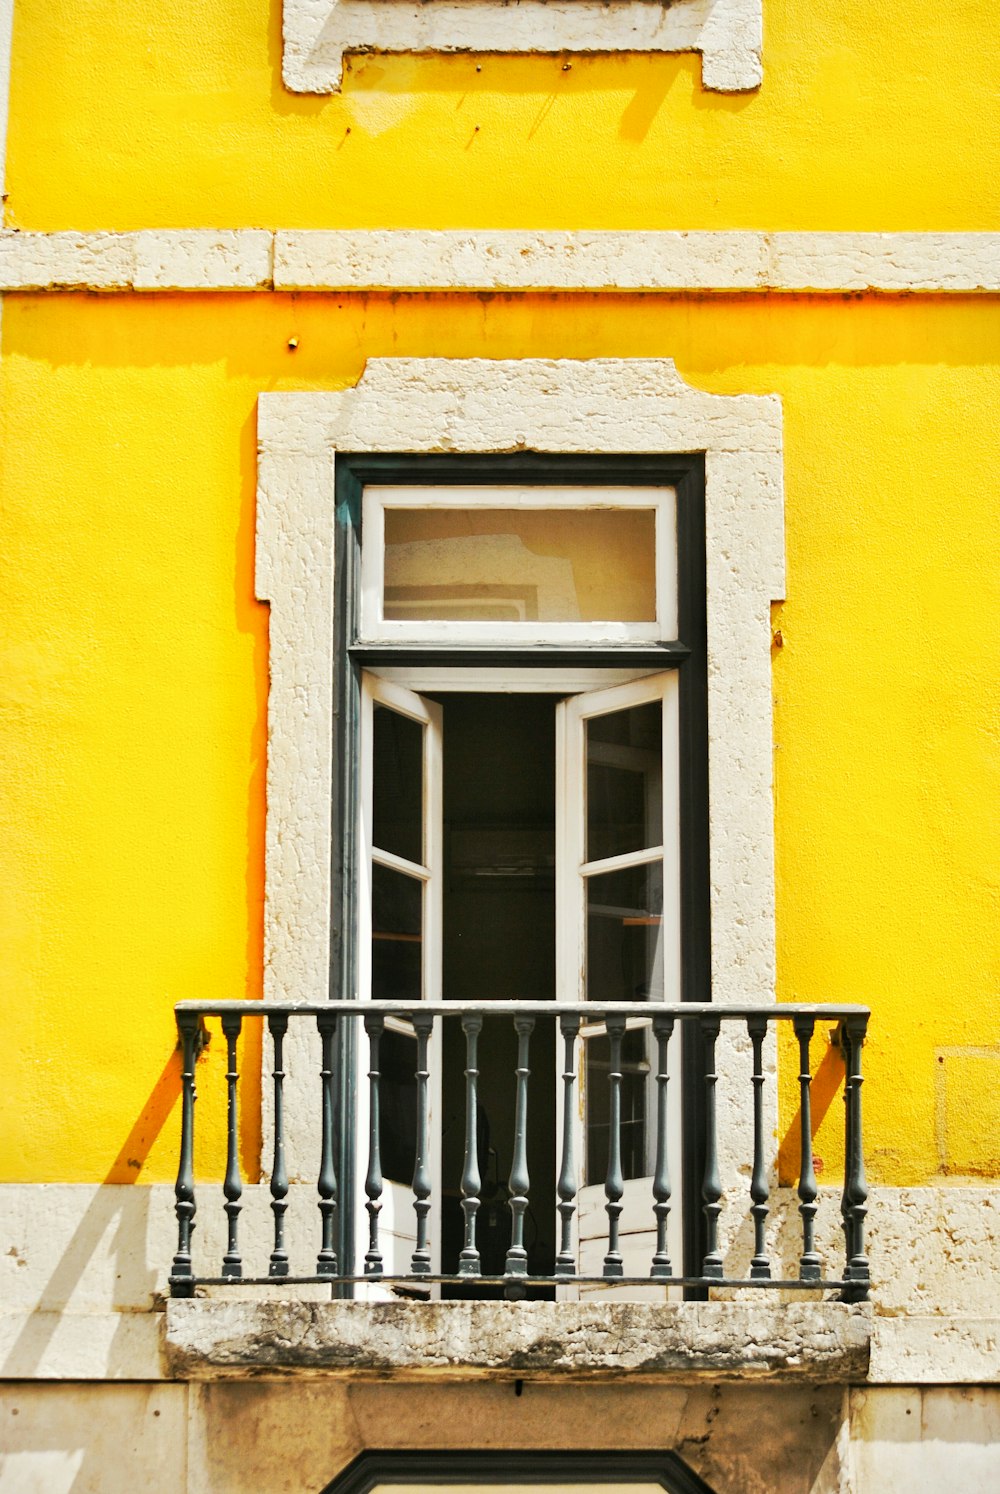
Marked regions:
[330,451,712,1298]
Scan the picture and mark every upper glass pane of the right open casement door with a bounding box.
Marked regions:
[584,701,664,861]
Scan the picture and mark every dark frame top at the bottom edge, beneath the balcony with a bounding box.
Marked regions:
[323,1448,713,1494]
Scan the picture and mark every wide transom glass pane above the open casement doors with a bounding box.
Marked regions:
[383,508,656,623]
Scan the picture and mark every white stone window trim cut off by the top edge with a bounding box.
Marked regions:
[276,0,764,94]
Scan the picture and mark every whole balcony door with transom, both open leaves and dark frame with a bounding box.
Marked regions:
[339,454,707,1300]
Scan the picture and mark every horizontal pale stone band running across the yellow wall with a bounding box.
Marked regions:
[0,229,1000,294]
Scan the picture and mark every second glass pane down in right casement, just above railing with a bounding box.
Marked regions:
[587,861,664,1001]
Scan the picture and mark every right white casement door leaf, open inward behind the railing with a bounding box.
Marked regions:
[556,672,683,1297]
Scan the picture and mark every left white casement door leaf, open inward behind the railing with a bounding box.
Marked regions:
[356,674,442,1276]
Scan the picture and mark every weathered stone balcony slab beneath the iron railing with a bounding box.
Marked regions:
[164,1298,873,1382]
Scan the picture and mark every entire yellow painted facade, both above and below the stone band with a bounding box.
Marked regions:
[0,0,1000,1213]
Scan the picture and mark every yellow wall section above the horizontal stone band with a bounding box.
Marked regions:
[6,0,1000,230]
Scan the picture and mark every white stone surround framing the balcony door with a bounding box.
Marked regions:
[256,359,785,1218]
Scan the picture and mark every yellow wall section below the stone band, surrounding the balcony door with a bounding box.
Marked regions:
[0,296,1000,1183]
